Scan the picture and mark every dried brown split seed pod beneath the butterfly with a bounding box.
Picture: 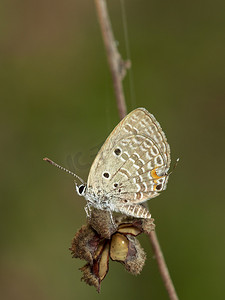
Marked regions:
[70,209,155,292]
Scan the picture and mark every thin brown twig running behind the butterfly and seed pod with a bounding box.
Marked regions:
[95,0,178,300]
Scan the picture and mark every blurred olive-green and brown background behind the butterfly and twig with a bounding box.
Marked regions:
[0,0,225,300]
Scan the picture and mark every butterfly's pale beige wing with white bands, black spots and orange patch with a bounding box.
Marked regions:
[87,108,170,206]
